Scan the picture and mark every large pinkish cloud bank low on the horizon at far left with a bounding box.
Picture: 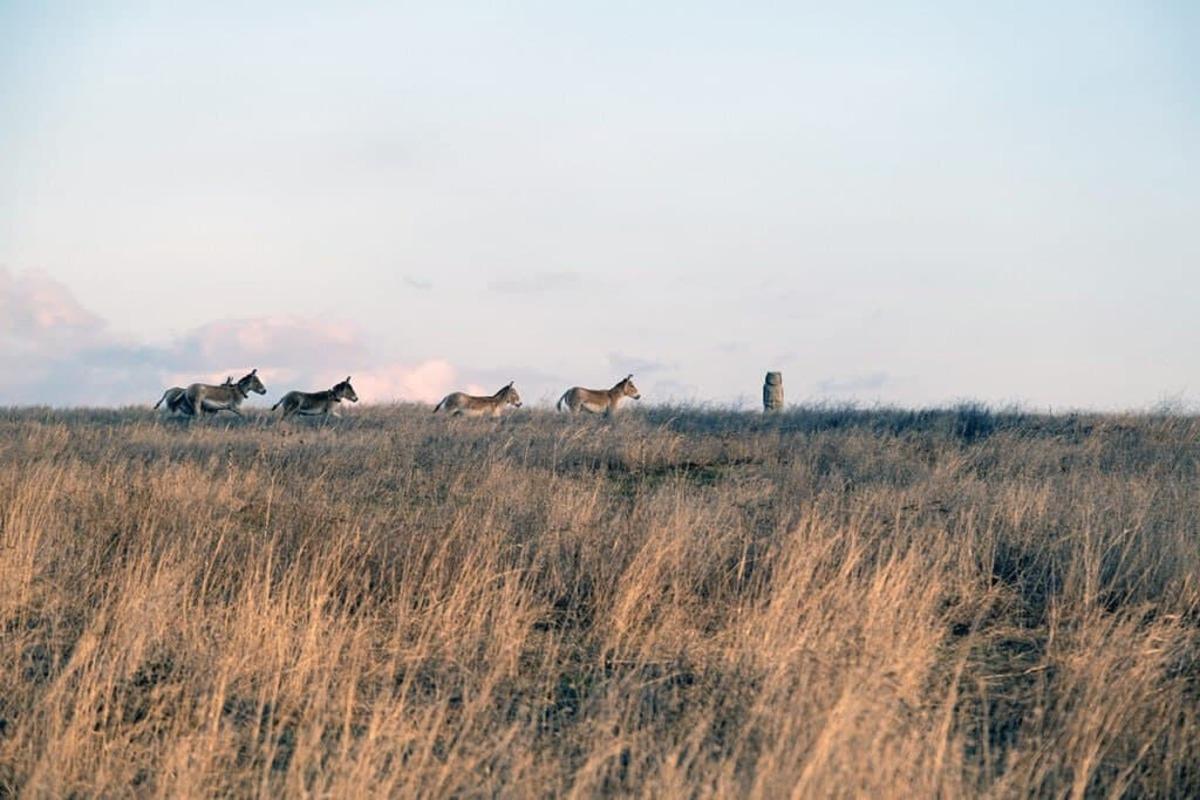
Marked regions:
[0,267,455,405]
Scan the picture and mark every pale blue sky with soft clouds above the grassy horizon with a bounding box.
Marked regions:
[0,0,1200,410]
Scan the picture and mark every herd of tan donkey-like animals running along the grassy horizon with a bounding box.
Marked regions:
[154,368,642,420]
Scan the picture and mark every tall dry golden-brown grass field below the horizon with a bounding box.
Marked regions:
[0,407,1200,798]
